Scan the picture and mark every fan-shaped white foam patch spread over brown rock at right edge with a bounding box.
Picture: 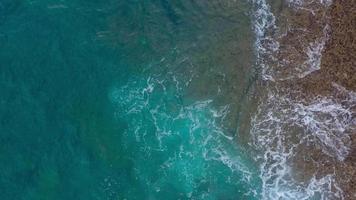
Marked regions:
[294,97,356,161]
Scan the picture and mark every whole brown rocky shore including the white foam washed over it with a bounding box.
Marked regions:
[253,0,356,200]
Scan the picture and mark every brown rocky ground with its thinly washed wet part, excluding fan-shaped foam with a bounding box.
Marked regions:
[258,0,356,200]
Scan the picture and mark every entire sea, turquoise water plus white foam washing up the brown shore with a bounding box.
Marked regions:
[0,0,356,200]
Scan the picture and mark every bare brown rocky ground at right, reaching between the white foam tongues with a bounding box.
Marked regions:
[287,0,356,200]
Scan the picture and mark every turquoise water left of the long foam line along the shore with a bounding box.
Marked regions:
[0,0,261,200]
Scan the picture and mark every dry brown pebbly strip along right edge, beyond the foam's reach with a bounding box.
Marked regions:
[320,0,356,200]
